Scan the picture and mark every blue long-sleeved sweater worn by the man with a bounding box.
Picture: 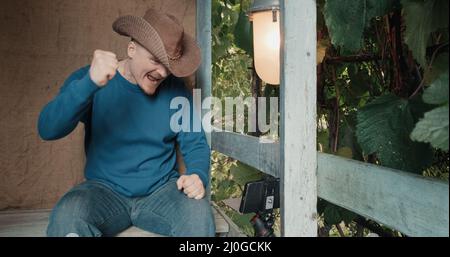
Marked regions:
[38,66,210,197]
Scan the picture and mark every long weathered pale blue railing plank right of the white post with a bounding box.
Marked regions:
[318,154,449,237]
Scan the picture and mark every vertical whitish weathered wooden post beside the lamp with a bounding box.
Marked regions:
[280,0,317,236]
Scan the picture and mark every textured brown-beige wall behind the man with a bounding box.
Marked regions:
[0,0,195,210]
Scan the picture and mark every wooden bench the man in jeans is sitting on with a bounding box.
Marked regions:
[0,205,229,237]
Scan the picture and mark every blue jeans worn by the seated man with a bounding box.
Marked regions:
[47,178,215,237]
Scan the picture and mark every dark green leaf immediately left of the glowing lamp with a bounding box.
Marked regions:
[234,11,253,56]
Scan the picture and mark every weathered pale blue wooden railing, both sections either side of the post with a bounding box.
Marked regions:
[212,132,449,236]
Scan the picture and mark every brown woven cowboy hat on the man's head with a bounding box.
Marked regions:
[113,9,201,77]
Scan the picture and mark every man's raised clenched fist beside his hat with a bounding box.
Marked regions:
[89,50,119,87]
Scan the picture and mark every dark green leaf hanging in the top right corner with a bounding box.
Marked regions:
[402,0,448,67]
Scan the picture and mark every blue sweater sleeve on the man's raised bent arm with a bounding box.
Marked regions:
[38,66,100,140]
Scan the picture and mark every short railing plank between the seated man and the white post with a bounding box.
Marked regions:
[211,131,280,177]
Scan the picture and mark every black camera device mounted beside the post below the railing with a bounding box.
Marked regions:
[239,176,280,237]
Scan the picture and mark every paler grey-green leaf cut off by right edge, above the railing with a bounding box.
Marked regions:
[411,104,449,151]
